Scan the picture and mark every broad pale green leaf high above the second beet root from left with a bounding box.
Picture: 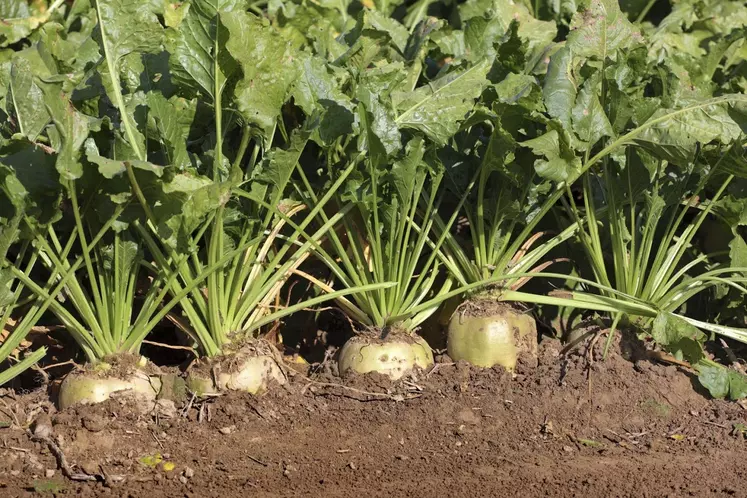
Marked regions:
[221,12,299,140]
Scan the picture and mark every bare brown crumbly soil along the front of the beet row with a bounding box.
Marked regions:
[0,330,747,498]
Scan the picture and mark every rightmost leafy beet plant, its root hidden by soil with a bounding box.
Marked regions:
[527,1,747,398]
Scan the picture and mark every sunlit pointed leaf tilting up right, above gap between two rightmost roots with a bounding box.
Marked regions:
[395,61,491,144]
